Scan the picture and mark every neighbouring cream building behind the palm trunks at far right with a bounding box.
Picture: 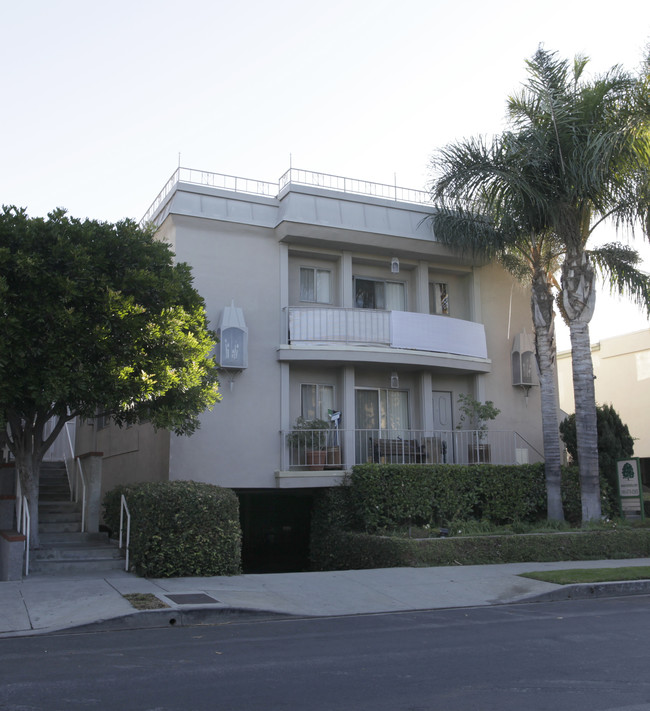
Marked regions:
[557,329,650,483]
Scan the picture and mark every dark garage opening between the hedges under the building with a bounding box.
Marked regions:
[237,491,314,573]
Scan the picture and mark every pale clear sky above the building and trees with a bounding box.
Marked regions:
[0,0,650,348]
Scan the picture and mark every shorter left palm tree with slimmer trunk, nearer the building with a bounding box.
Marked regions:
[432,133,564,521]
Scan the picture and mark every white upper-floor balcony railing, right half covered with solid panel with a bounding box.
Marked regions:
[287,306,487,358]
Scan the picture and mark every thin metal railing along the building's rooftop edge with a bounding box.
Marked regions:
[140,167,431,225]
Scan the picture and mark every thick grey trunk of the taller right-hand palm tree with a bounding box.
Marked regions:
[562,253,601,523]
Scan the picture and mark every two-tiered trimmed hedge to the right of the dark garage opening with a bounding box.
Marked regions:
[311,464,616,570]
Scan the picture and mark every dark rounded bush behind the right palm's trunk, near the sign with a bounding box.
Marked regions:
[560,404,634,508]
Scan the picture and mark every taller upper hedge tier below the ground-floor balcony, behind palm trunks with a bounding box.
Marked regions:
[349,464,616,533]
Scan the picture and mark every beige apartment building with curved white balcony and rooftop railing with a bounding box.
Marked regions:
[77,169,542,569]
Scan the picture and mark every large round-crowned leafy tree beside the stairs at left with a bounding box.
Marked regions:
[0,207,220,547]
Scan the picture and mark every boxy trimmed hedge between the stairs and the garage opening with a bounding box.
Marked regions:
[103,481,241,578]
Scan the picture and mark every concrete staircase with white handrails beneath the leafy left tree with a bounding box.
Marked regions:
[29,462,124,575]
